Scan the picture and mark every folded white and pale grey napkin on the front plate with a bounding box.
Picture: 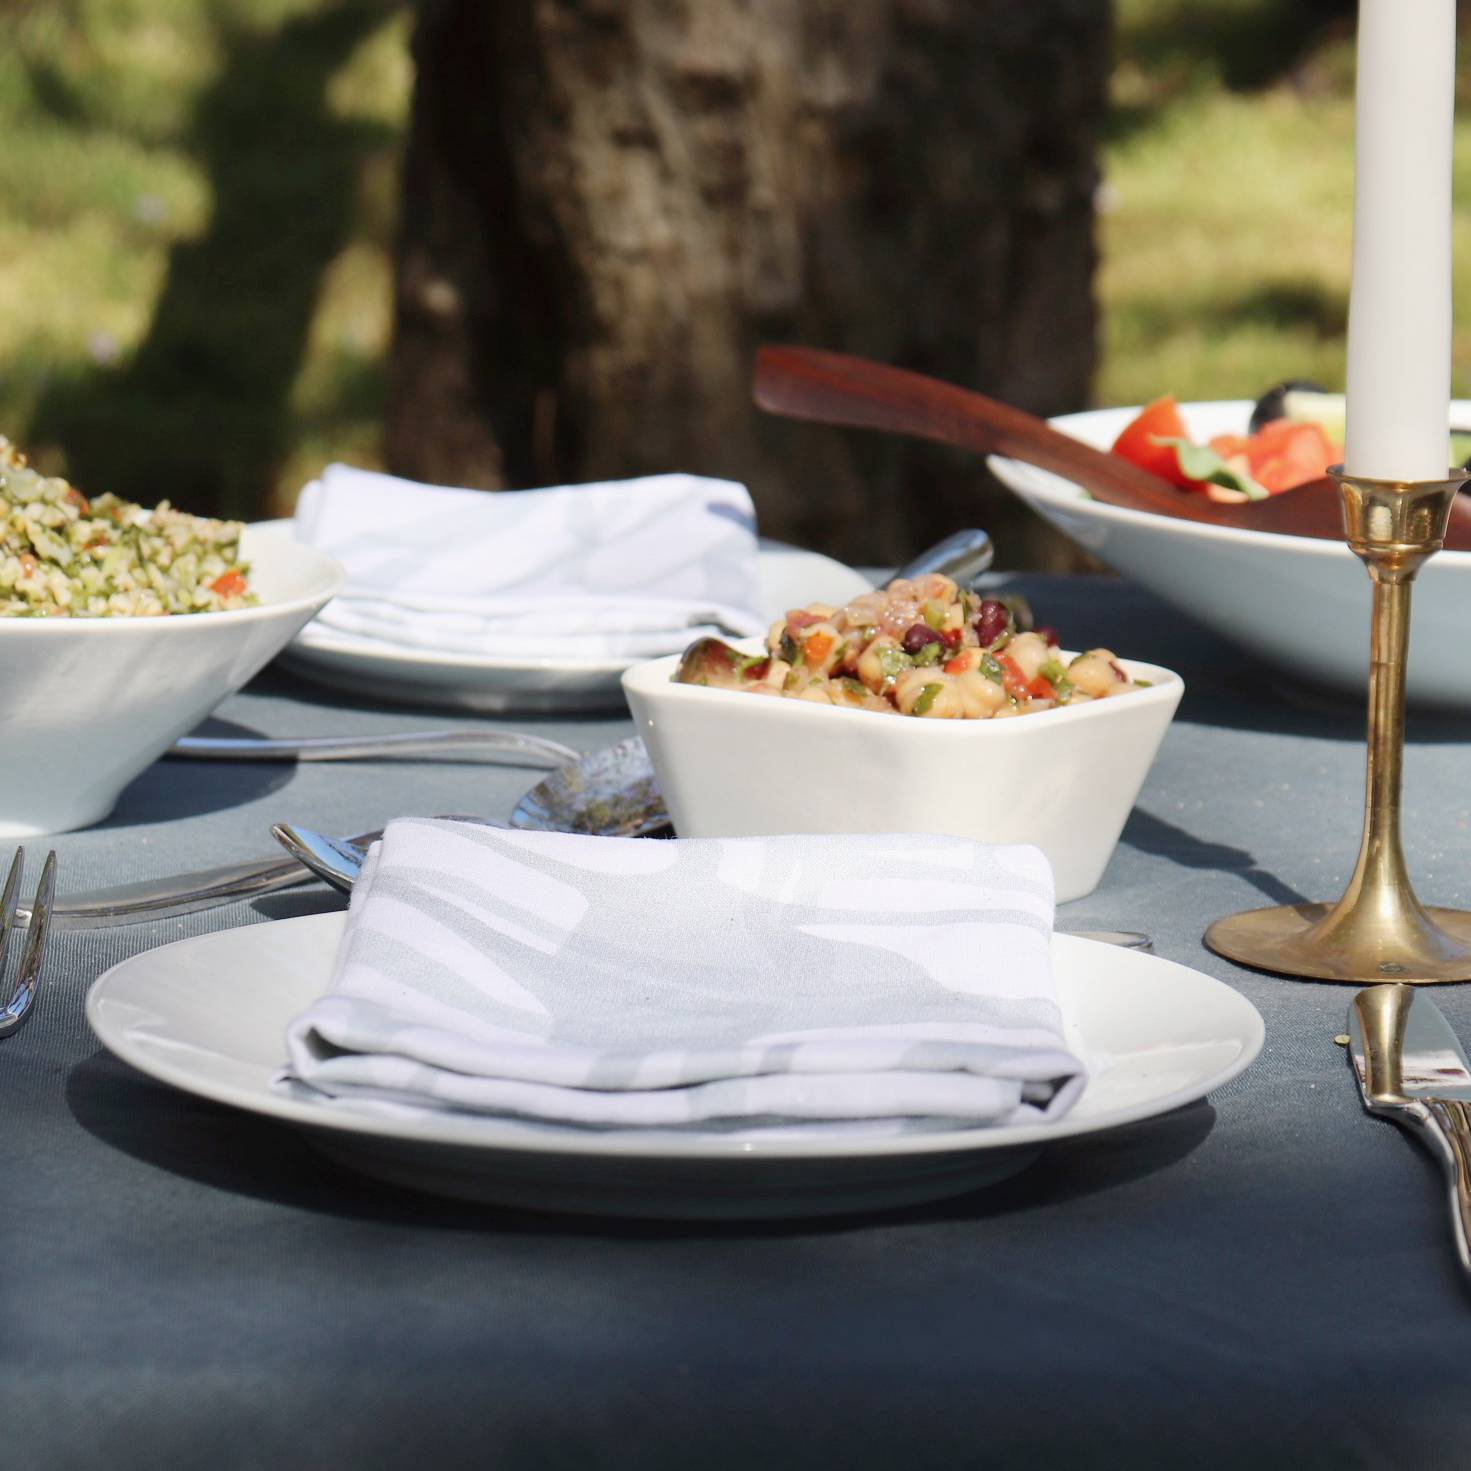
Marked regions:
[279,818,1086,1137]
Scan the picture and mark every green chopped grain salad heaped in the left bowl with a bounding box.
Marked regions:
[0,435,256,618]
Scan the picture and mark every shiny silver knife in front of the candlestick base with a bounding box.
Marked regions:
[1349,986,1471,1278]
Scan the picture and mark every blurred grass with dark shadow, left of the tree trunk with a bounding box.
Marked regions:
[0,0,410,515]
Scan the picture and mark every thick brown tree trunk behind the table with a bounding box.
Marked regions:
[388,0,1108,565]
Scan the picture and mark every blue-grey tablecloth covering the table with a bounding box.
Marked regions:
[0,578,1471,1471]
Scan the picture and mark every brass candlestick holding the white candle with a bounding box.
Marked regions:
[1205,466,1471,986]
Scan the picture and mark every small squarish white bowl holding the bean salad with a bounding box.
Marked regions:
[624,640,1184,902]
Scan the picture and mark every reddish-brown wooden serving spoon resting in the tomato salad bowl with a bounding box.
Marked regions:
[752,347,1471,552]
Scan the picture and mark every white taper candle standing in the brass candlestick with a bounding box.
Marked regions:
[1343,0,1456,480]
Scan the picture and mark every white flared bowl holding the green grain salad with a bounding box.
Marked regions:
[0,527,343,837]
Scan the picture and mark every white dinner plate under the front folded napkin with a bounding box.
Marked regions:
[87,913,1262,1219]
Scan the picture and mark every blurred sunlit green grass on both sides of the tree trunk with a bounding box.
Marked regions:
[0,0,1471,515]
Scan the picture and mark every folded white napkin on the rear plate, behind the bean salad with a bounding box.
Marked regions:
[296,465,765,659]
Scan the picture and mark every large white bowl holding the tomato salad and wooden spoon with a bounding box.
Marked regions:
[989,400,1471,709]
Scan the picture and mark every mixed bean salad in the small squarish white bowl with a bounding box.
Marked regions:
[675,572,1144,719]
